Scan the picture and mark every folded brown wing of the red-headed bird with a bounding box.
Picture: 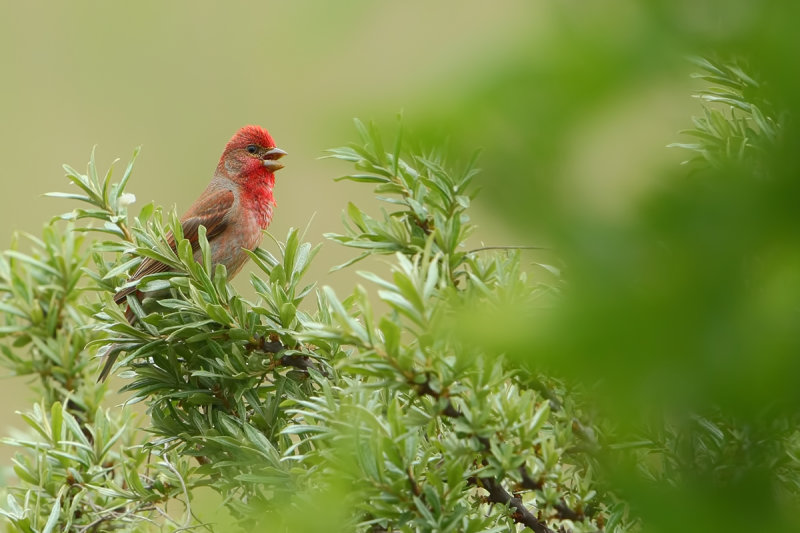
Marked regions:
[114,189,235,304]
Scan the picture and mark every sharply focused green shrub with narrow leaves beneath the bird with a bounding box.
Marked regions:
[0,122,629,532]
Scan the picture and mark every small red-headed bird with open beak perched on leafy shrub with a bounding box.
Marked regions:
[98,126,286,381]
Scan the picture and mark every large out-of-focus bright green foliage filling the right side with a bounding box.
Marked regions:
[406,1,800,531]
